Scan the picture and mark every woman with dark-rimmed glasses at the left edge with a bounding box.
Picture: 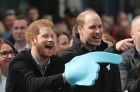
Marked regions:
[0,38,17,92]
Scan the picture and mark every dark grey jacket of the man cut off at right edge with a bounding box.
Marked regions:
[119,48,140,92]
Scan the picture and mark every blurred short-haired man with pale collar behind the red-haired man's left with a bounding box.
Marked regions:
[12,16,29,52]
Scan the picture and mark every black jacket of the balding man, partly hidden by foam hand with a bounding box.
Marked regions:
[61,39,121,92]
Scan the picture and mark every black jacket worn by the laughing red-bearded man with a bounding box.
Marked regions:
[6,50,64,92]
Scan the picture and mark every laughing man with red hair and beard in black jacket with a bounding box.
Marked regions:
[6,20,64,92]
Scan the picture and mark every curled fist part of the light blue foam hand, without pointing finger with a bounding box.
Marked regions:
[64,58,100,86]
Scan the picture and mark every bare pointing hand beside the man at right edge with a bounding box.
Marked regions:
[116,38,134,51]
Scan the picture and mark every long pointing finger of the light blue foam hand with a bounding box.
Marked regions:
[75,51,122,64]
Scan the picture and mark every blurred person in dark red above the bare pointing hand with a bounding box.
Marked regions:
[111,11,131,42]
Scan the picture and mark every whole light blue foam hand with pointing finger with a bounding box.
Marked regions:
[64,52,122,86]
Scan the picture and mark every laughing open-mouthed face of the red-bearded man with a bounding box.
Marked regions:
[36,26,55,58]
